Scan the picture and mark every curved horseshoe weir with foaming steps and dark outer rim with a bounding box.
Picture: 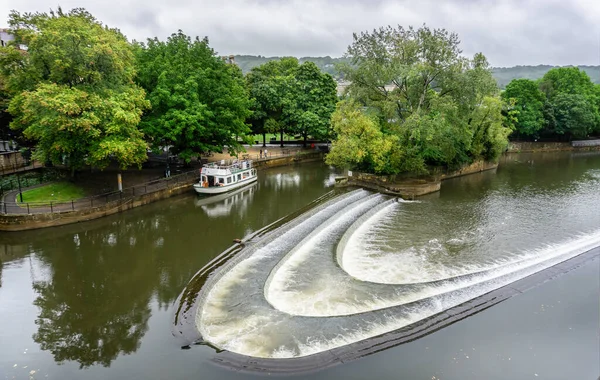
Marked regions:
[172,168,600,372]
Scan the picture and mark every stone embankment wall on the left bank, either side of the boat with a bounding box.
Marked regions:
[0,151,323,231]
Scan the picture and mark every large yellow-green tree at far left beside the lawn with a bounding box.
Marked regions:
[0,8,149,173]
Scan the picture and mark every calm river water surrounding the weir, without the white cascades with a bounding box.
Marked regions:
[0,153,600,380]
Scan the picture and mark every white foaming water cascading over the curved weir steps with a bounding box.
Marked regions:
[196,190,600,358]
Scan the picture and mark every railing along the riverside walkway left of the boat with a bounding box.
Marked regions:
[0,169,199,214]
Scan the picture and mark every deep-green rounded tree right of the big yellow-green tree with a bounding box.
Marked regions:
[137,31,250,162]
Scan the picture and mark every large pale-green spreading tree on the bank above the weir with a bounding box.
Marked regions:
[331,26,509,174]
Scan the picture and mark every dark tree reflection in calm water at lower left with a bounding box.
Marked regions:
[33,218,159,368]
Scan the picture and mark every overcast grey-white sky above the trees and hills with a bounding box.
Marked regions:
[0,0,600,66]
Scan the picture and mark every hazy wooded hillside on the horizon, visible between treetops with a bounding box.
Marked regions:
[235,55,600,88]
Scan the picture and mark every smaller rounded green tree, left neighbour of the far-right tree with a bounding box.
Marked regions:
[502,79,546,137]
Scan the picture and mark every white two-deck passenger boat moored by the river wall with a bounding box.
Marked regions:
[194,160,257,194]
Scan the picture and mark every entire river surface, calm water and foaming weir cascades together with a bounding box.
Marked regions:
[0,153,600,379]
